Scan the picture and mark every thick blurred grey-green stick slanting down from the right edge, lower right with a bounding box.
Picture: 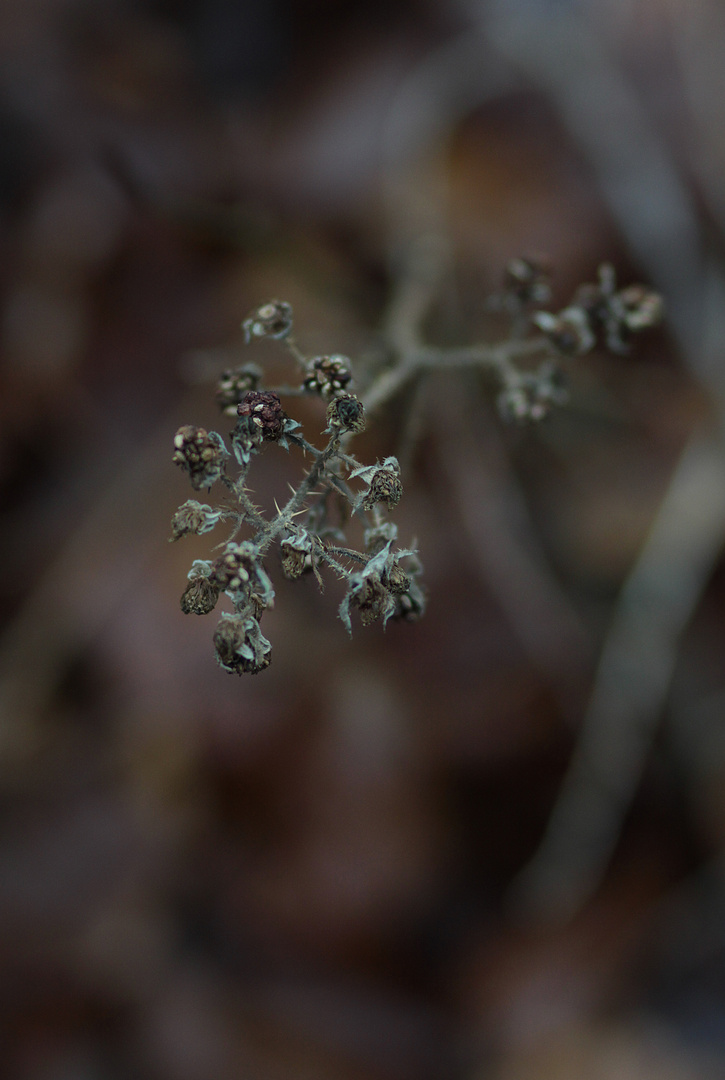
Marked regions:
[512,435,725,918]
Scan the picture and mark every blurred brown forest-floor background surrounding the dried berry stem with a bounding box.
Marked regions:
[7,0,725,1080]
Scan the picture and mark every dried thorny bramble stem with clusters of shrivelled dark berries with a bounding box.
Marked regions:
[172,257,662,675]
